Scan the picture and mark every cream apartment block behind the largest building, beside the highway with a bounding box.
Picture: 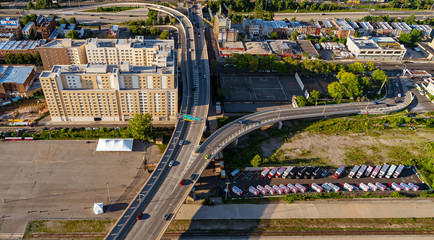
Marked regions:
[86,36,174,67]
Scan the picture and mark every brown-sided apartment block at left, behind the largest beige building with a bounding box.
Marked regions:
[38,38,87,70]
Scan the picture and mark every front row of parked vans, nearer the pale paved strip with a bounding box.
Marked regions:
[231,182,419,196]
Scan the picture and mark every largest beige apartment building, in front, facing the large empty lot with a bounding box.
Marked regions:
[40,60,178,122]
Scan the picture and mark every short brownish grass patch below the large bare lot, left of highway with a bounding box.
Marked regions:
[25,219,116,236]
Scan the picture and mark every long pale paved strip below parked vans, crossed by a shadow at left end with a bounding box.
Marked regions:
[176,199,434,219]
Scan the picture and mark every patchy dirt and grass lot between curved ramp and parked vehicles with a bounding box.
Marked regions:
[261,125,434,166]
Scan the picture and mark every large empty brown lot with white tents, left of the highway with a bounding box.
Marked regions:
[0,141,157,235]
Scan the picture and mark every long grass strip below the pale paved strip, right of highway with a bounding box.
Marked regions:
[167,218,434,234]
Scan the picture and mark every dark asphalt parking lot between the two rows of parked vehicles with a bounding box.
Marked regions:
[228,166,429,197]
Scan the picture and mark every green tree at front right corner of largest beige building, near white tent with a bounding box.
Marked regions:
[127,113,152,140]
